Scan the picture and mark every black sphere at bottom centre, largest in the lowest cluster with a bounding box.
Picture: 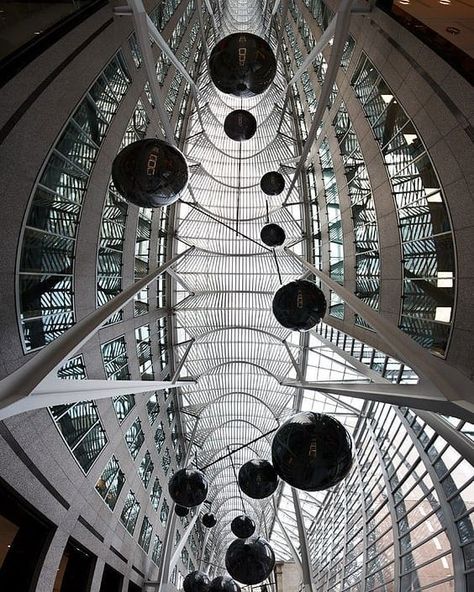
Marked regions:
[225,537,275,584]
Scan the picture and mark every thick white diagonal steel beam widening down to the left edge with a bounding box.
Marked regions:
[0,247,194,409]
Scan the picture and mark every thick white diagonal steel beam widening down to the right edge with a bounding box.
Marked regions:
[285,247,474,416]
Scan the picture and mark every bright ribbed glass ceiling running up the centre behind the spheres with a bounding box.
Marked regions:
[173,0,376,567]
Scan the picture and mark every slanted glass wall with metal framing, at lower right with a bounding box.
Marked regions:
[309,374,462,590]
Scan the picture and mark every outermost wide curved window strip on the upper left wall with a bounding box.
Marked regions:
[19,52,131,351]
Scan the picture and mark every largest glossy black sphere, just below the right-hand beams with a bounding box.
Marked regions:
[272,411,352,491]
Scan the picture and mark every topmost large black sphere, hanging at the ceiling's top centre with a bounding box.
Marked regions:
[209,33,276,97]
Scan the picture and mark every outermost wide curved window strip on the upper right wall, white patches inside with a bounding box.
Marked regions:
[352,55,456,355]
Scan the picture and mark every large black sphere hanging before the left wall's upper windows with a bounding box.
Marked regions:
[112,138,188,208]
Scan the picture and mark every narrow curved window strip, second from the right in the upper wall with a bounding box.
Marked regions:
[333,102,380,327]
